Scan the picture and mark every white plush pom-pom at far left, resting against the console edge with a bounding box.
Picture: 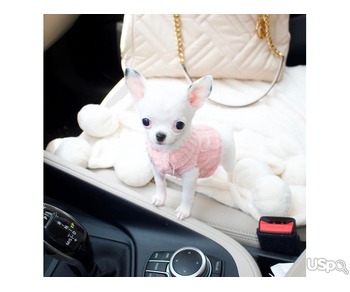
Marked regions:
[54,137,91,168]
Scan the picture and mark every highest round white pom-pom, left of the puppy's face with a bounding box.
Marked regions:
[78,104,119,138]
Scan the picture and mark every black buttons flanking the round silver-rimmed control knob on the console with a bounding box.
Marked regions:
[144,248,224,277]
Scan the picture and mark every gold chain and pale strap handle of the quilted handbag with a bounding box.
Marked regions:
[173,14,285,107]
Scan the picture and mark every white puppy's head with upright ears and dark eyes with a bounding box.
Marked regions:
[125,68,213,151]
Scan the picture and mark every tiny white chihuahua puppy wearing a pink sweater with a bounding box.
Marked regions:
[125,68,235,219]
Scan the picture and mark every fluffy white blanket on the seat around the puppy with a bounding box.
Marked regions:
[47,66,306,225]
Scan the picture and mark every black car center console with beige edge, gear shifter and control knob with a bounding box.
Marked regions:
[43,153,261,277]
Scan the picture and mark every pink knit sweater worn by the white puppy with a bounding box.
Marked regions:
[147,125,222,177]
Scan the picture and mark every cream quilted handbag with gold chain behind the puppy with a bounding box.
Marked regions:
[121,14,290,106]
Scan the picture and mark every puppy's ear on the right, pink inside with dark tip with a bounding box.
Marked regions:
[187,75,213,109]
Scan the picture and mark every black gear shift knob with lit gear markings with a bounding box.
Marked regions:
[44,204,98,276]
